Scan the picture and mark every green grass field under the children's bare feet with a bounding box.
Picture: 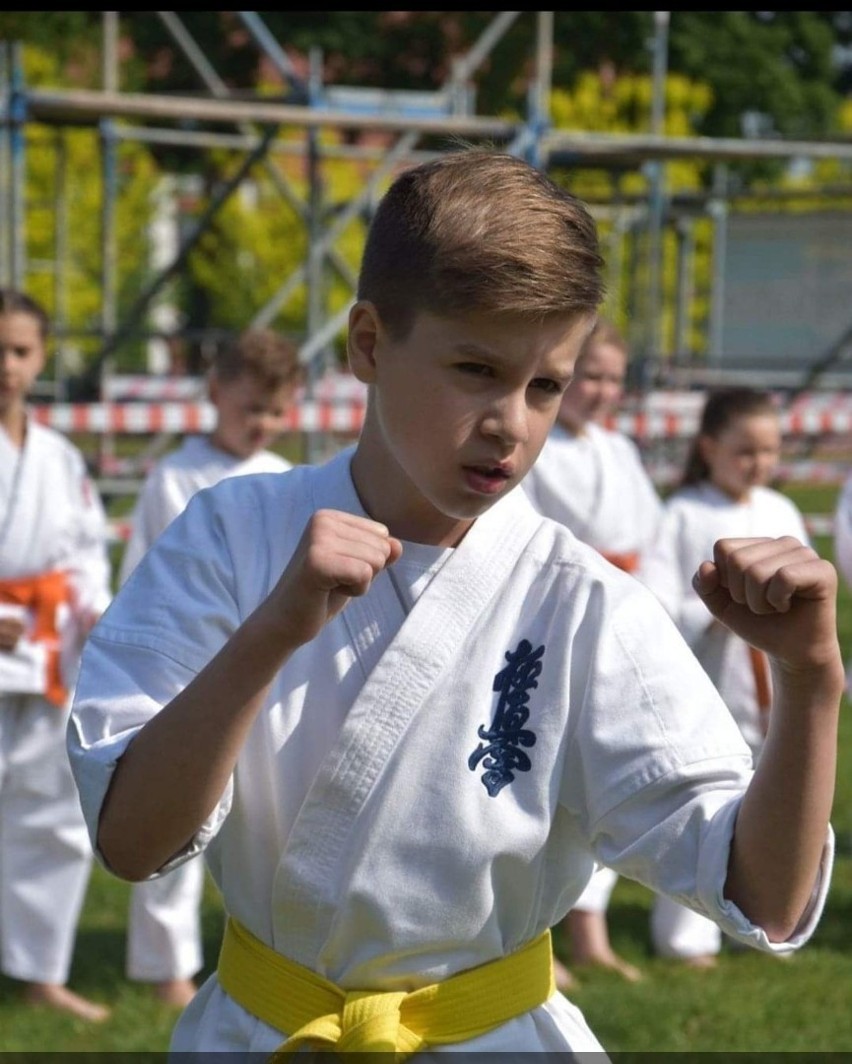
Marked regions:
[0,478,852,1053]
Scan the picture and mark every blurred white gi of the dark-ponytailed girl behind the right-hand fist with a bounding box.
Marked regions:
[637,482,811,958]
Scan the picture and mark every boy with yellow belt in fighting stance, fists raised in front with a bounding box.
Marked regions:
[68,149,843,1058]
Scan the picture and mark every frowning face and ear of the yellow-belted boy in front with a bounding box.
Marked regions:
[349,302,594,546]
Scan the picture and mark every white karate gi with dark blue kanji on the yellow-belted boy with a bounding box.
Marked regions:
[68,448,834,1052]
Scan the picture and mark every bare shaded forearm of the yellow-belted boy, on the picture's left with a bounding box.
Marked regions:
[98,606,295,880]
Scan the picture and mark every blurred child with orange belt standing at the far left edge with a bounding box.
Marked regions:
[0,288,110,1021]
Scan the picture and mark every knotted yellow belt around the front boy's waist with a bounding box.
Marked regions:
[218,917,555,1061]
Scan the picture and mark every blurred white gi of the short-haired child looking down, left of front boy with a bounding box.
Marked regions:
[119,436,291,983]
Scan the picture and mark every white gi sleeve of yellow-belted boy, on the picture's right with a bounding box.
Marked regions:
[563,582,834,953]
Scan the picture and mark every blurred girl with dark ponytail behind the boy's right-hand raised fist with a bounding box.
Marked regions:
[638,387,809,967]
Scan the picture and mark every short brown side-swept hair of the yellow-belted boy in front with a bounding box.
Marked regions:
[357,148,604,336]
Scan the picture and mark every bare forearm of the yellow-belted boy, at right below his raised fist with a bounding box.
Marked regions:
[725,663,843,942]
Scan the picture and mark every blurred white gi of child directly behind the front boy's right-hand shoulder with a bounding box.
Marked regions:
[523,421,663,913]
